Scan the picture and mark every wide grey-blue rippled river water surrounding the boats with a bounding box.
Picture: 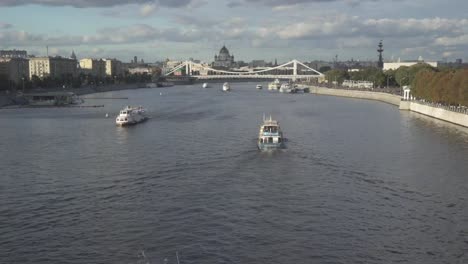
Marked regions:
[0,83,468,264]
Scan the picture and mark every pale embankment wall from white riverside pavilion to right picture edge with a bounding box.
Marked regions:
[400,101,468,127]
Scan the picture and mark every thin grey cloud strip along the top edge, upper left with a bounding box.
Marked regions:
[0,0,193,8]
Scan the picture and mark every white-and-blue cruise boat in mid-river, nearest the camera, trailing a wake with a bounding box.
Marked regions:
[257,116,283,150]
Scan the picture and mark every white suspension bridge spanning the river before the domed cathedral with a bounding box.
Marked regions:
[164,60,325,80]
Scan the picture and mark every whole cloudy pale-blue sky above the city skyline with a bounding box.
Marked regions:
[0,0,468,62]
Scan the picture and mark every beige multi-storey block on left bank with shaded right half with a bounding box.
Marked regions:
[29,56,77,78]
